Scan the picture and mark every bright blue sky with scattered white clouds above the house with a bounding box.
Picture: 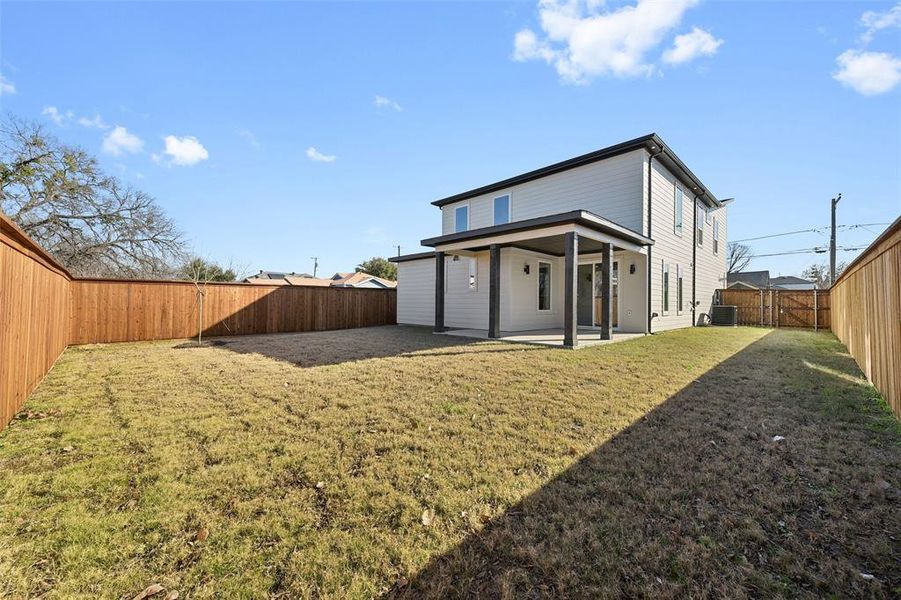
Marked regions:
[0,0,901,274]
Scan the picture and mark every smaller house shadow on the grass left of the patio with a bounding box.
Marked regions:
[176,325,539,367]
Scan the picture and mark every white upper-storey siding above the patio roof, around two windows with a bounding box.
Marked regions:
[441,150,647,235]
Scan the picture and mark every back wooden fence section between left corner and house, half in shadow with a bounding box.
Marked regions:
[69,279,397,344]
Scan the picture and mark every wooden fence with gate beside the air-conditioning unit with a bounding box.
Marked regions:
[717,289,832,329]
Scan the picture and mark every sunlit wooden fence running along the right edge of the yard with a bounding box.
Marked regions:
[831,217,901,418]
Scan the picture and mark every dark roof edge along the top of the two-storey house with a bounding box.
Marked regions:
[432,133,722,207]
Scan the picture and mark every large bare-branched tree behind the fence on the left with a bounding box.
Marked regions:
[0,116,184,278]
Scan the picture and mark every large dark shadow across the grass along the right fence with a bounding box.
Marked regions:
[388,331,901,598]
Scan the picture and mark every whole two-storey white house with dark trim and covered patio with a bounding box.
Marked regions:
[391,134,727,346]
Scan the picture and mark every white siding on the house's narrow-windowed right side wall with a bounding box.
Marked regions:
[643,155,727,331]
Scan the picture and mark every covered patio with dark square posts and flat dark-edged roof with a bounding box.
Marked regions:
[422,210,654,348]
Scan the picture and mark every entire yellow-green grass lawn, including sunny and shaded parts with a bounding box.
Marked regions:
[0,327,901,598]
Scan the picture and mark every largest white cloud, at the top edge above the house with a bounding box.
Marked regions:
[513,0,712,83]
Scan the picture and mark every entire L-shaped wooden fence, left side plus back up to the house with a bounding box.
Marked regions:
[0,214,397,430]
